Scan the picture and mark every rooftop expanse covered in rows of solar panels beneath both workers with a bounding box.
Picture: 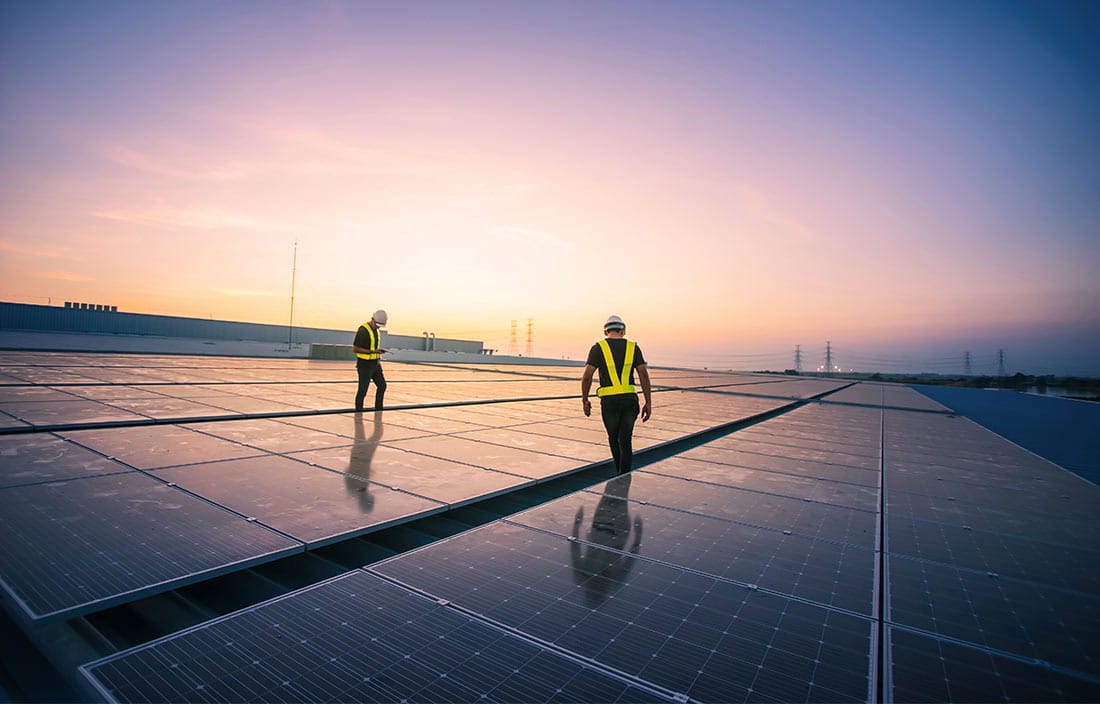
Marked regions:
[0,351,1100,702]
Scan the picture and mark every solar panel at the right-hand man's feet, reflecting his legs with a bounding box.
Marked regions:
[509,472,876,615]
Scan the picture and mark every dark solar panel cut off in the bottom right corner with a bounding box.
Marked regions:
[888,628,1100,704]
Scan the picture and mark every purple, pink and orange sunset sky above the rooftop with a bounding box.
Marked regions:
[0,0,1100,375]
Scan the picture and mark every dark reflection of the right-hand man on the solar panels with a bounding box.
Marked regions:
[570,474,641,607]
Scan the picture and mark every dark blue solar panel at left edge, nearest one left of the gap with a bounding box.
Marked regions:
[0,472,303,619]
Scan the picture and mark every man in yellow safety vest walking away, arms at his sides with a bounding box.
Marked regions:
[581,316,652,474]
